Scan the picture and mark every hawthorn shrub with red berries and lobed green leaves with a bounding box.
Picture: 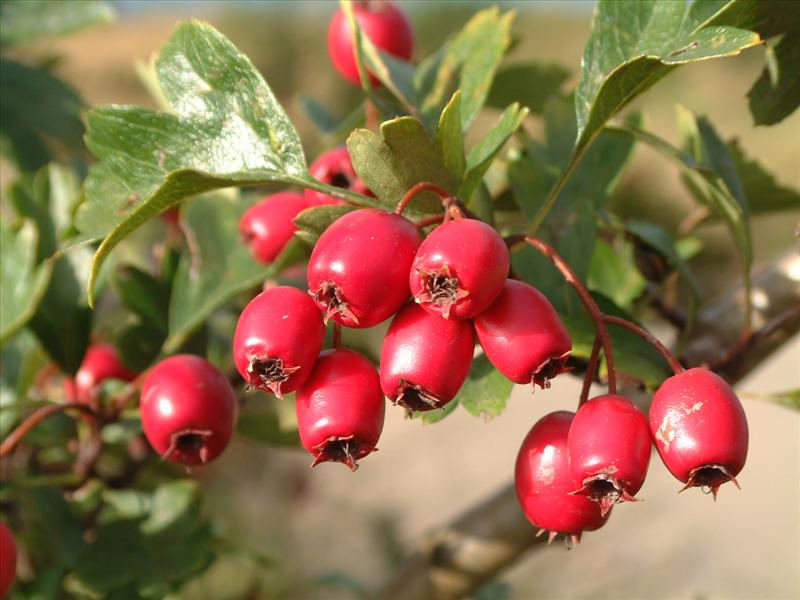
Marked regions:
[0,0,800,598]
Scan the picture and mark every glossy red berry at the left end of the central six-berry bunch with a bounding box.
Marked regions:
[233,286,325,398]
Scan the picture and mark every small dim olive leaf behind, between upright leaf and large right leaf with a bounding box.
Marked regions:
[486,62,569,115]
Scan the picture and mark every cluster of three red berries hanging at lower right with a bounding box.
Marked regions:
[515,368,748,542]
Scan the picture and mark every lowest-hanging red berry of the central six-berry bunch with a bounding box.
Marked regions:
[296,348,385,470]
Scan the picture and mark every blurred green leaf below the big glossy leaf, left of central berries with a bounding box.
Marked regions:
[164,194,303,354]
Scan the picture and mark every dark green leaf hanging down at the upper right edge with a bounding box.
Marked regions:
[747,30,800,125]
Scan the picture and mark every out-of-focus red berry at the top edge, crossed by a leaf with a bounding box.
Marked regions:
[328,2,414,85]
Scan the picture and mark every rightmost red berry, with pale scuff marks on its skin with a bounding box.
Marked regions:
[650,368,748,498]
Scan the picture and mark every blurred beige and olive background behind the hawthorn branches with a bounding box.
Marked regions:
[0,0,800,600]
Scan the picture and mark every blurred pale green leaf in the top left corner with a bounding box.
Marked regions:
[0,0,114,46]
